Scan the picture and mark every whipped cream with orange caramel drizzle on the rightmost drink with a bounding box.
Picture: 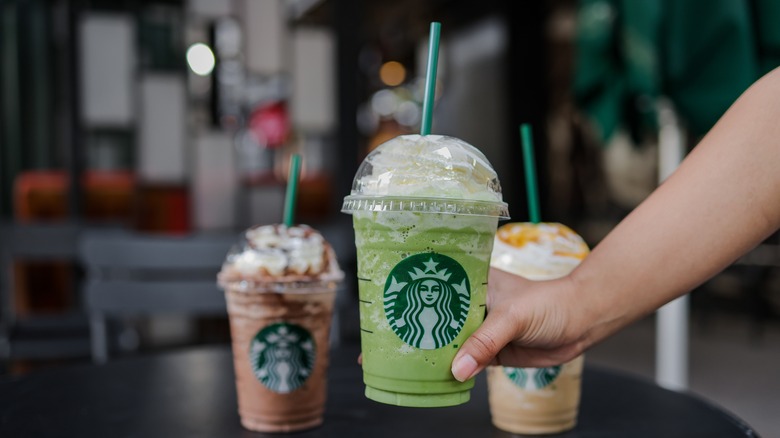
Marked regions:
[490,222,589,280]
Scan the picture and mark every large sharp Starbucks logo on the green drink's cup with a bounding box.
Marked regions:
[384,253,471,350]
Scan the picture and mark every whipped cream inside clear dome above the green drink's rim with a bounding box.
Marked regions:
[352,134,502,202]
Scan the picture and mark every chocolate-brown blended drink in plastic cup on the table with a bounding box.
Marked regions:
[218,225,344,432]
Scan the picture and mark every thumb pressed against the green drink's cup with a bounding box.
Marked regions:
[452,308,515,382]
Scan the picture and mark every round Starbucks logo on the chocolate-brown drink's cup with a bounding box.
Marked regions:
[249,322,315,394]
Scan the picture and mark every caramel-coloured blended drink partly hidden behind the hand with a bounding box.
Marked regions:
[487,222,589,435]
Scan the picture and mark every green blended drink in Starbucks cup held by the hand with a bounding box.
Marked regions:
[342,135,508,407]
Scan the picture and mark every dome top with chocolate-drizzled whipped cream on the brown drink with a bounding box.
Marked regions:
[217,224,344,292]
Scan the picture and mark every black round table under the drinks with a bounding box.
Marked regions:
[0,346,758,438]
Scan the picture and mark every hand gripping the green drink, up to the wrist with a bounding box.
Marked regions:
[452,268,585,382]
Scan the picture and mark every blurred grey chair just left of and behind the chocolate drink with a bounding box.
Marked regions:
[79,231,239,363]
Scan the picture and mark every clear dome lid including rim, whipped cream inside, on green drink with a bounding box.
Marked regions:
[341,134,509,219]
